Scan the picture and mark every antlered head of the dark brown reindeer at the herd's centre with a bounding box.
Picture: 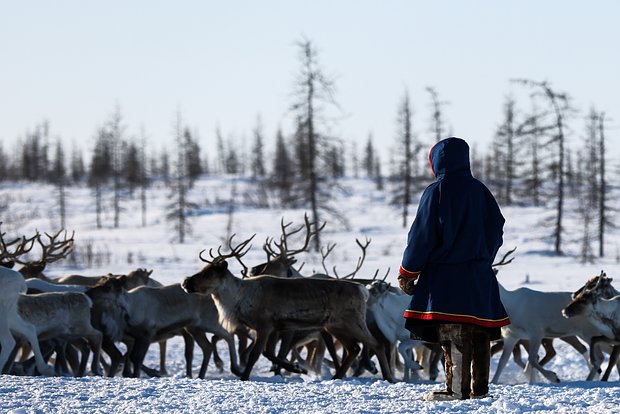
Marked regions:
[182,234,255,294]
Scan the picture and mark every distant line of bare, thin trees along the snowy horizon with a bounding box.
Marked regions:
[0,40,617,260]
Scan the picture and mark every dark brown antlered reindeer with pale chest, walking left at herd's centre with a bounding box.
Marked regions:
[183,235,393,382]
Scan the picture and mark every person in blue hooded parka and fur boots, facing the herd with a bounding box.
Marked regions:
[398,137,510,400]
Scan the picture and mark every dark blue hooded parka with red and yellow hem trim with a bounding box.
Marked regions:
[400,137,510,342]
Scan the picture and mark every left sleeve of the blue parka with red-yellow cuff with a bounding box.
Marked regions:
[399,183,440,278]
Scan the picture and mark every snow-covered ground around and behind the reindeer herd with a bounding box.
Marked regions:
[0,177,620,413]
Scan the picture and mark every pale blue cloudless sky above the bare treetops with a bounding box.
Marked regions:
[0,0,620,159]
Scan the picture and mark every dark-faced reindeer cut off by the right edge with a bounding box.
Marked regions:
[562,271,620,381]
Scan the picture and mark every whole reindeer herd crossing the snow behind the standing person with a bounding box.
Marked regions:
[0,216,620,382]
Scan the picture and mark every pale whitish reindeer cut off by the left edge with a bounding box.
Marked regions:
[0,222,54,375]
